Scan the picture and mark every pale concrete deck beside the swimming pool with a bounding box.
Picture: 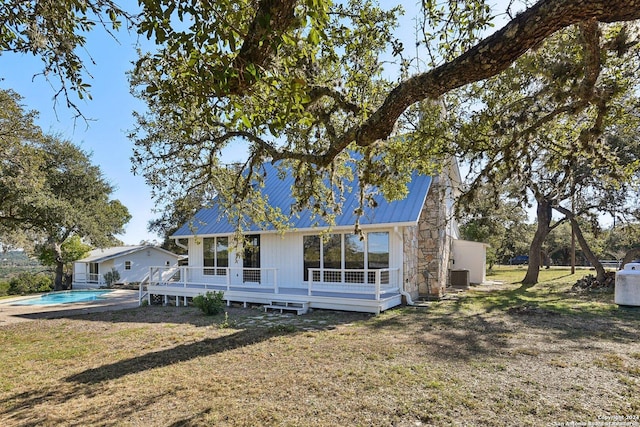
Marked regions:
[0,289,138,327]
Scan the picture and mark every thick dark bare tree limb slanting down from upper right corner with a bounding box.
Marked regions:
[336,0,640,155]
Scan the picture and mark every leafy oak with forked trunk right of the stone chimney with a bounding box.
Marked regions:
[454,21,640,283]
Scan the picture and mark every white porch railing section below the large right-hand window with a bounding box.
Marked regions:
[309,268,400,300]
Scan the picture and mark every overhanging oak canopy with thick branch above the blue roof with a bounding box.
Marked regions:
[132,0,640,234]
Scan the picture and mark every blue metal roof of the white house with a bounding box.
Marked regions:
[172,164,431,238]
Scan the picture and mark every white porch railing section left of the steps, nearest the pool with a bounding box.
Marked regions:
[148,266,278,293]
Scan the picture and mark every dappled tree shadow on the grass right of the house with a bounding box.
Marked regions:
[369,285,640,361]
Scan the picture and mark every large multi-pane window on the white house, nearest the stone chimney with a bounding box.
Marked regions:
[303,232,389,283]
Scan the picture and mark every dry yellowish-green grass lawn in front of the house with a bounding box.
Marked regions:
[0,268,640,426]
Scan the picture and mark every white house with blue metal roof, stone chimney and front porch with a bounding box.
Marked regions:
[140,161,484,313]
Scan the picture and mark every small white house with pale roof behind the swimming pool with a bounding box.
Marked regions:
[73,245,181,288]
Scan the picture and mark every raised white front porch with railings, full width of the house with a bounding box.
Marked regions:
[139,266,402,313]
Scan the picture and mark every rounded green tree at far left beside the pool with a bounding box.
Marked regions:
[0,91,131,289]
